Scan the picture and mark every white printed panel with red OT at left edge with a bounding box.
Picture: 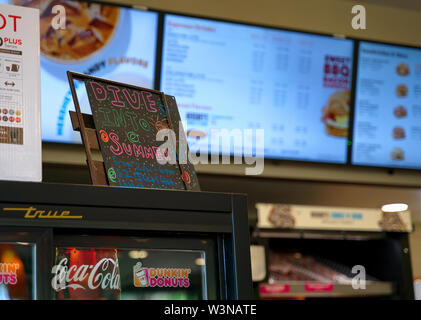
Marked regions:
[0,4,42,181]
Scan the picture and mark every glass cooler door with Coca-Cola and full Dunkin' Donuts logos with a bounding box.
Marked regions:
[51,236,218,300]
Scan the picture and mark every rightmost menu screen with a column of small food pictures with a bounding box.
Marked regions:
[352,42,421,169]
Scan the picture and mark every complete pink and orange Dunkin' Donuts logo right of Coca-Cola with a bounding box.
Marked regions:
[133,262,191,288]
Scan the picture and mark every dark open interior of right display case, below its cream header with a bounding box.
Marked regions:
[252,229,414,299]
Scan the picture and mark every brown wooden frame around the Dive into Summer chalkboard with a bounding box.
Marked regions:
[67,71,200,191]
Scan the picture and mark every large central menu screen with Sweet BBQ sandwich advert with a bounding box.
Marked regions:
[161,15,353,163]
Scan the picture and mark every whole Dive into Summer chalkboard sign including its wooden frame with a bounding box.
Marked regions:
[67,72,200,190]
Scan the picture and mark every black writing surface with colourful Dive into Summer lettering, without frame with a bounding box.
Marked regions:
[84,78,199,190]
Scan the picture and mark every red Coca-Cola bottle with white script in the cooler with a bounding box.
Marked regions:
[51,247,121,300]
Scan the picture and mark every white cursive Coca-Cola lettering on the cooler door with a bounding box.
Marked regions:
[51,258,120,292]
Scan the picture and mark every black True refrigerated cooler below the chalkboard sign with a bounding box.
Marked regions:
[0,182,253,300]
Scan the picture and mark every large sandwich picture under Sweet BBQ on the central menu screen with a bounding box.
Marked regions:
[322,90,350,137]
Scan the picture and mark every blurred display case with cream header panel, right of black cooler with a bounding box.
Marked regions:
[251,204,414,300]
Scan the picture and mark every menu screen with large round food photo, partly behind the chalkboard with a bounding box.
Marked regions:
[0,0,158,143]
